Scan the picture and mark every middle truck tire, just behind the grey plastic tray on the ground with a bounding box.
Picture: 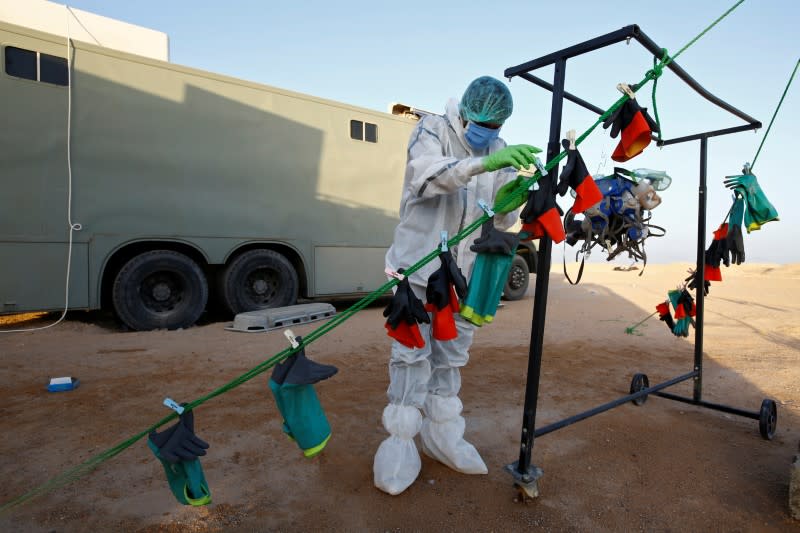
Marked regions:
[221,250,300,315]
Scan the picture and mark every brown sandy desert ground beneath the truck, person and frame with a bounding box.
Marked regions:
[0,264,800,532]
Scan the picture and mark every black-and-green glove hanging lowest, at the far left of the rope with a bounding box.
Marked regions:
[147,404,211,506]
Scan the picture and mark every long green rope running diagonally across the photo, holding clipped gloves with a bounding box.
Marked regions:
[0,0,744,516]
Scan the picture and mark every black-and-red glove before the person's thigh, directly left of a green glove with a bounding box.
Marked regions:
[425,250,467,341]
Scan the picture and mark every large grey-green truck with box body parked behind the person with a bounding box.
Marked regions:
[0,22,535,330]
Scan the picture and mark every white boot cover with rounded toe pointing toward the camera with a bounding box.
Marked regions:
[372,404,422,496]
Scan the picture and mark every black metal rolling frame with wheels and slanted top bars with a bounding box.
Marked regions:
[504,24,777,496]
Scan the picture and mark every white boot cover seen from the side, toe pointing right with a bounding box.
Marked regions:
[420,394,489,474]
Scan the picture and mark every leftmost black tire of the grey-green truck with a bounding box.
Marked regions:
[112,250,208,331]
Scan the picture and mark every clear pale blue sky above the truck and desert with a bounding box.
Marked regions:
[57,0,800,263]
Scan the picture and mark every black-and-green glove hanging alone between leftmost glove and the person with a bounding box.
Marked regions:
[269,337,339,458]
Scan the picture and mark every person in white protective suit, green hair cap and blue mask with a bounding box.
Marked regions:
[373,76,540,494]
